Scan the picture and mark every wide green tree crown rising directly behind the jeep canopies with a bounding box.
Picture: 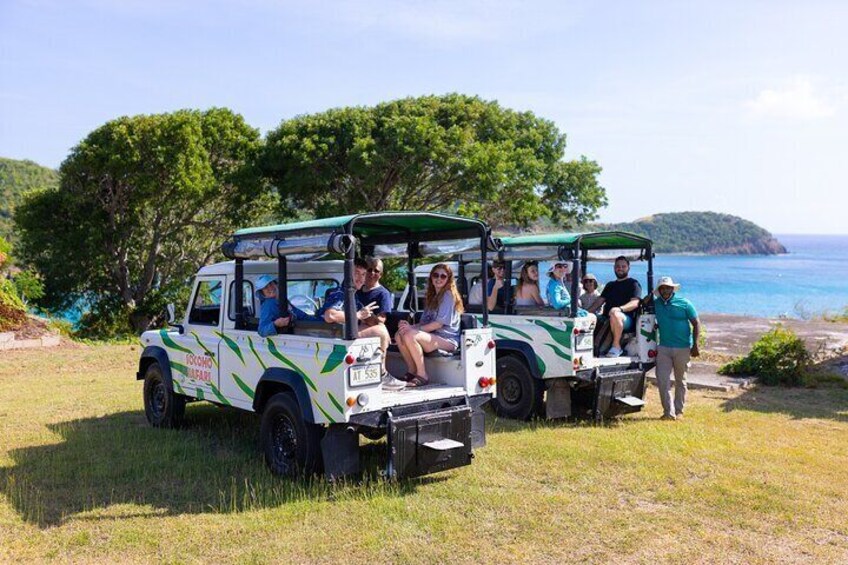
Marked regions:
[262,94,606,226]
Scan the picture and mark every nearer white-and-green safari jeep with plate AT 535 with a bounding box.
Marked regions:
[137,212,498,478]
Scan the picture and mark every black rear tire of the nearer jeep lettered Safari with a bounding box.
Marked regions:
[259,392,324,478]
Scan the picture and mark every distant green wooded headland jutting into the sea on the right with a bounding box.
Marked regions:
[587,212,786,255]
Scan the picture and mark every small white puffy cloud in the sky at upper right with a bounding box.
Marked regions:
[746,77,836,119]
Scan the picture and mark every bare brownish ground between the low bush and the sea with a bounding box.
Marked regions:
[648,314,848,390]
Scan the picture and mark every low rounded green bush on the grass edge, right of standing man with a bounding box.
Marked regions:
[718,326,812,386]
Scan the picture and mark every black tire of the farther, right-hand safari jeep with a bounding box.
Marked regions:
[492,355,545,420]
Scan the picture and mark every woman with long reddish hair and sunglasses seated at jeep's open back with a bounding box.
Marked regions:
[395,263,463,387]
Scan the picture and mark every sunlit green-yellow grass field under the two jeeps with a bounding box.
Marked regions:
[0,345,848,563]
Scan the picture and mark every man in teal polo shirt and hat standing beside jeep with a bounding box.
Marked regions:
[654,277,701,420]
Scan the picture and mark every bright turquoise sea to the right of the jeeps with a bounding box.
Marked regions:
[616,235,848,318]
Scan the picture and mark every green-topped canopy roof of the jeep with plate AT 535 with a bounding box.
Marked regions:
[222,212,499,259]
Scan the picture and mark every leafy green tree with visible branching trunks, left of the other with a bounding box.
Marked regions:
[15,109,269,333]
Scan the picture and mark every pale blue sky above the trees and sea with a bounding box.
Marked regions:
[0,0,848,233]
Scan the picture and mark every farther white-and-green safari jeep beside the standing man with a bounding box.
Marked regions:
[402,232,657,421]
